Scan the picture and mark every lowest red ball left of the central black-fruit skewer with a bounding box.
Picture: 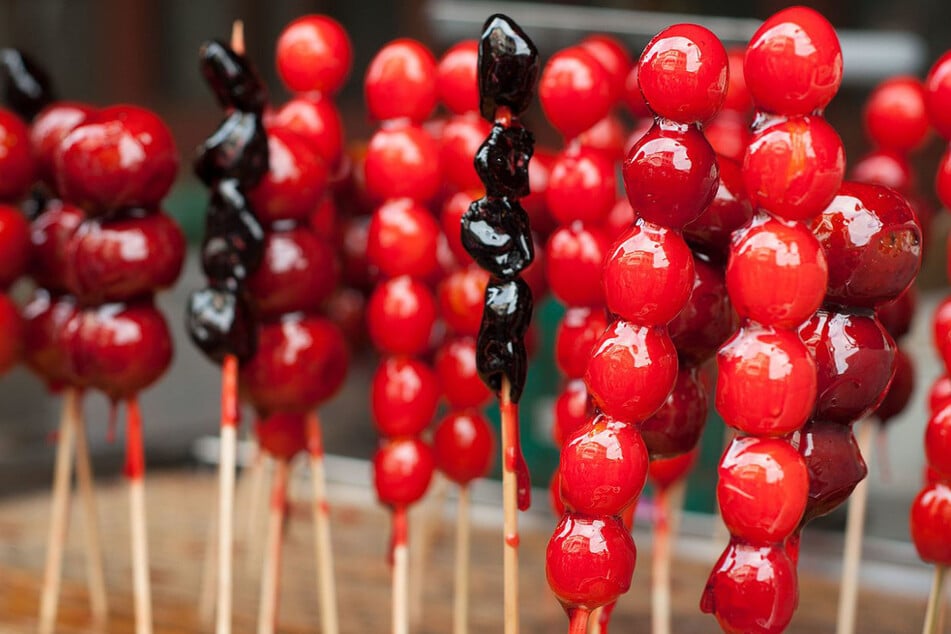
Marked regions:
[373,438,436,506]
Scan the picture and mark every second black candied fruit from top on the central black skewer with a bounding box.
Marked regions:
[475,119,535,198]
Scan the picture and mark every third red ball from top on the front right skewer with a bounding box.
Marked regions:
[726,213,829,328]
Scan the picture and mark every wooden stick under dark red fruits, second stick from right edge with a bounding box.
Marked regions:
[835,419,875,634]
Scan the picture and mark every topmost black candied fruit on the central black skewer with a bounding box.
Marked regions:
[479,14,538,120]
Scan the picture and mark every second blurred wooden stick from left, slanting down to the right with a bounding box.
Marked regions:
[71,388,109,625]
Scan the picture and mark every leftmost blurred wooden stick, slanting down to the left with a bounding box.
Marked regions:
[39,390,76,634]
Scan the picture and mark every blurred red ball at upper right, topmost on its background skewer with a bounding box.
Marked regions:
[862,76,928,152]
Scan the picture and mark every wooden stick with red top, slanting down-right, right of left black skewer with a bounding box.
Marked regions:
[307,413,340,634]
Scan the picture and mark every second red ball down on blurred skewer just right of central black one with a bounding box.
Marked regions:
[545,146,617,224]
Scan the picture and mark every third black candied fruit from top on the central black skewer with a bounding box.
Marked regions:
[462,198,535,279]
